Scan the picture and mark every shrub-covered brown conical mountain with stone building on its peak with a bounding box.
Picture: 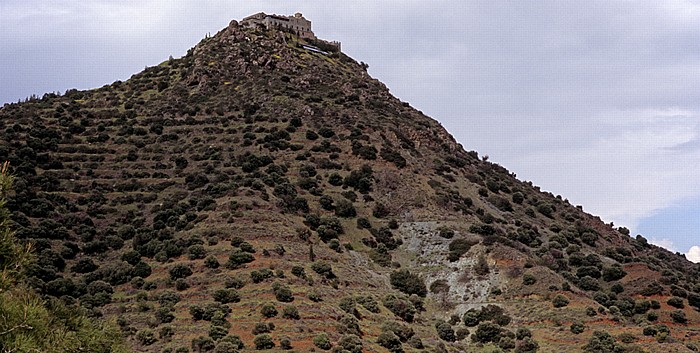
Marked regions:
[0,13,700,352]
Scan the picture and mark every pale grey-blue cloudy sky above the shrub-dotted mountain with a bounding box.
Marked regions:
[0,0,700,261]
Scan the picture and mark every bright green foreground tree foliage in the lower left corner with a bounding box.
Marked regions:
[0,162,127,353]
